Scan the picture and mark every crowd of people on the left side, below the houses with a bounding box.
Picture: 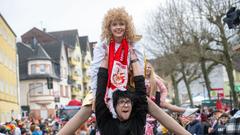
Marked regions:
[0,117,96,135]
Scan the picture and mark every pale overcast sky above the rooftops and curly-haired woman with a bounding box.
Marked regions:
[0,0,163,41]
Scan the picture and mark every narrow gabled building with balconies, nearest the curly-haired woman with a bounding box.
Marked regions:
[79,36,92,97]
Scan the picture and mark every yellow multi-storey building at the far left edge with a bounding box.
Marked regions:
[0,14,20,122]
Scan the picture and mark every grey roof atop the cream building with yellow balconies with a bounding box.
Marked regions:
[48,29,78,48]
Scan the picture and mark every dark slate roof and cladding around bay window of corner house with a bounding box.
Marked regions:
[17,42,61,80]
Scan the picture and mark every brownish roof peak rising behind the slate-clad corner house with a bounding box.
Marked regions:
[21,27,57,44]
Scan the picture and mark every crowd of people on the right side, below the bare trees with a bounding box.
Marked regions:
[145,107,240,135]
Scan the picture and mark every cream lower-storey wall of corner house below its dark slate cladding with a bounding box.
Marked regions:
[20,79,61,119]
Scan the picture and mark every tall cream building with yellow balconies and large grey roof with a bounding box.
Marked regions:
[48,30,83,100]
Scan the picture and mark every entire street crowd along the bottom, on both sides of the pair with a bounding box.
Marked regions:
[0,106,240,135]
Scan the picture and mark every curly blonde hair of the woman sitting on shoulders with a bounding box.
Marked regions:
[101,7,137,42]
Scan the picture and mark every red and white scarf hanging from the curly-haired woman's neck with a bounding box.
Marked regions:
[105,38,128,118]
